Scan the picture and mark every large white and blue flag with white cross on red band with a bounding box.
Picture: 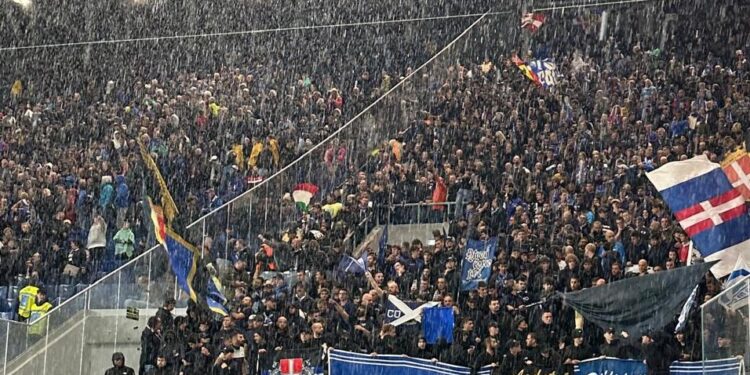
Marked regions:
[647,155,750,277]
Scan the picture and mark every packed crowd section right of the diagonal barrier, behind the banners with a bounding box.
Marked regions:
[106,8,749,374]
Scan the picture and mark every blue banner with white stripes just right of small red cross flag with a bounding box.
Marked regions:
[328,349,492,375]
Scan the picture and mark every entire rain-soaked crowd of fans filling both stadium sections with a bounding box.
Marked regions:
[0,0,750,375]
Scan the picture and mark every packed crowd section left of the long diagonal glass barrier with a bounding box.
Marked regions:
[0,9,482,317]
